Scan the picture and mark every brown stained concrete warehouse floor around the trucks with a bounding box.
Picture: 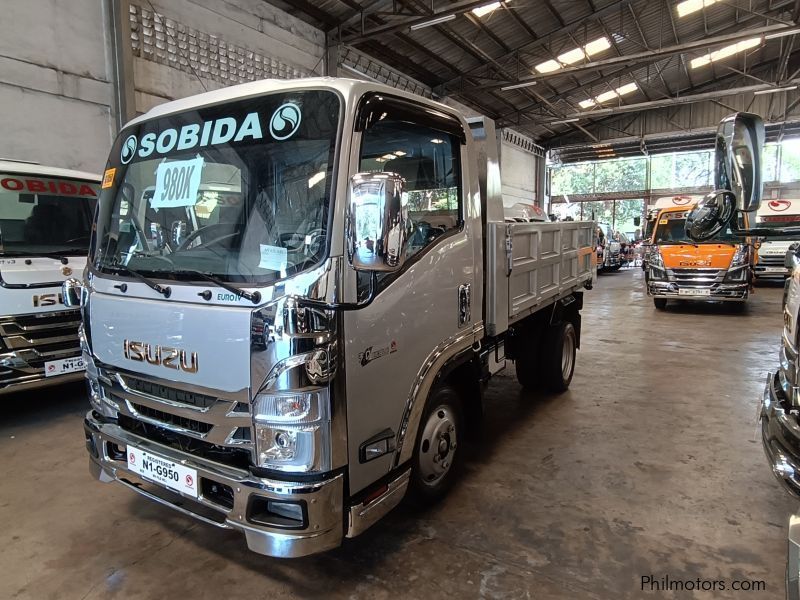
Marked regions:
[0,269,796,600]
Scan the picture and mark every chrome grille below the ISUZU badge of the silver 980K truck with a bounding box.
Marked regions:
[99,368,254,462]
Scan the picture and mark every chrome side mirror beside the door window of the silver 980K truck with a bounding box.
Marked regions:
[346,173,410,272]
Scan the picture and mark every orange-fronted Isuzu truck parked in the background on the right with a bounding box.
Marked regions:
[645,196,755,310]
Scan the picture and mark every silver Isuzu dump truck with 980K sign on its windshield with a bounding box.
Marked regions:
[70,78,594,557]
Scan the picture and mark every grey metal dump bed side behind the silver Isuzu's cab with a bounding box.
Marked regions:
[485,221,595,335]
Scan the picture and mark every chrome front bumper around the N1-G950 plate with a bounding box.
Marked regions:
[84,412,347,558]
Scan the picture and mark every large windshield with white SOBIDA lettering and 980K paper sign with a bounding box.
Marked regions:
[92,90,341,284]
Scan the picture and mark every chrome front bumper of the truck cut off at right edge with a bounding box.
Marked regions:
[759,374,800,500]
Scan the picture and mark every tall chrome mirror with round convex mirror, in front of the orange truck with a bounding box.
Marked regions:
[686,113,764,242]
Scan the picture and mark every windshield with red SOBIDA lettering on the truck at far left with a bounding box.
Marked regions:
[0,173,100,256]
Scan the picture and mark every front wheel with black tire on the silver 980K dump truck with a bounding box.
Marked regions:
[408,385,465,507]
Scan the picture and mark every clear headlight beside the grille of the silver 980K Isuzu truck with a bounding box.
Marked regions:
[253,388,330,472]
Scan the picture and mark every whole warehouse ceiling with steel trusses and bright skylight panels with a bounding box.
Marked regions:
[271,0,800,152]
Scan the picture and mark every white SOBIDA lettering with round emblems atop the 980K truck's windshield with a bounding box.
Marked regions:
[119,102,302,165]
